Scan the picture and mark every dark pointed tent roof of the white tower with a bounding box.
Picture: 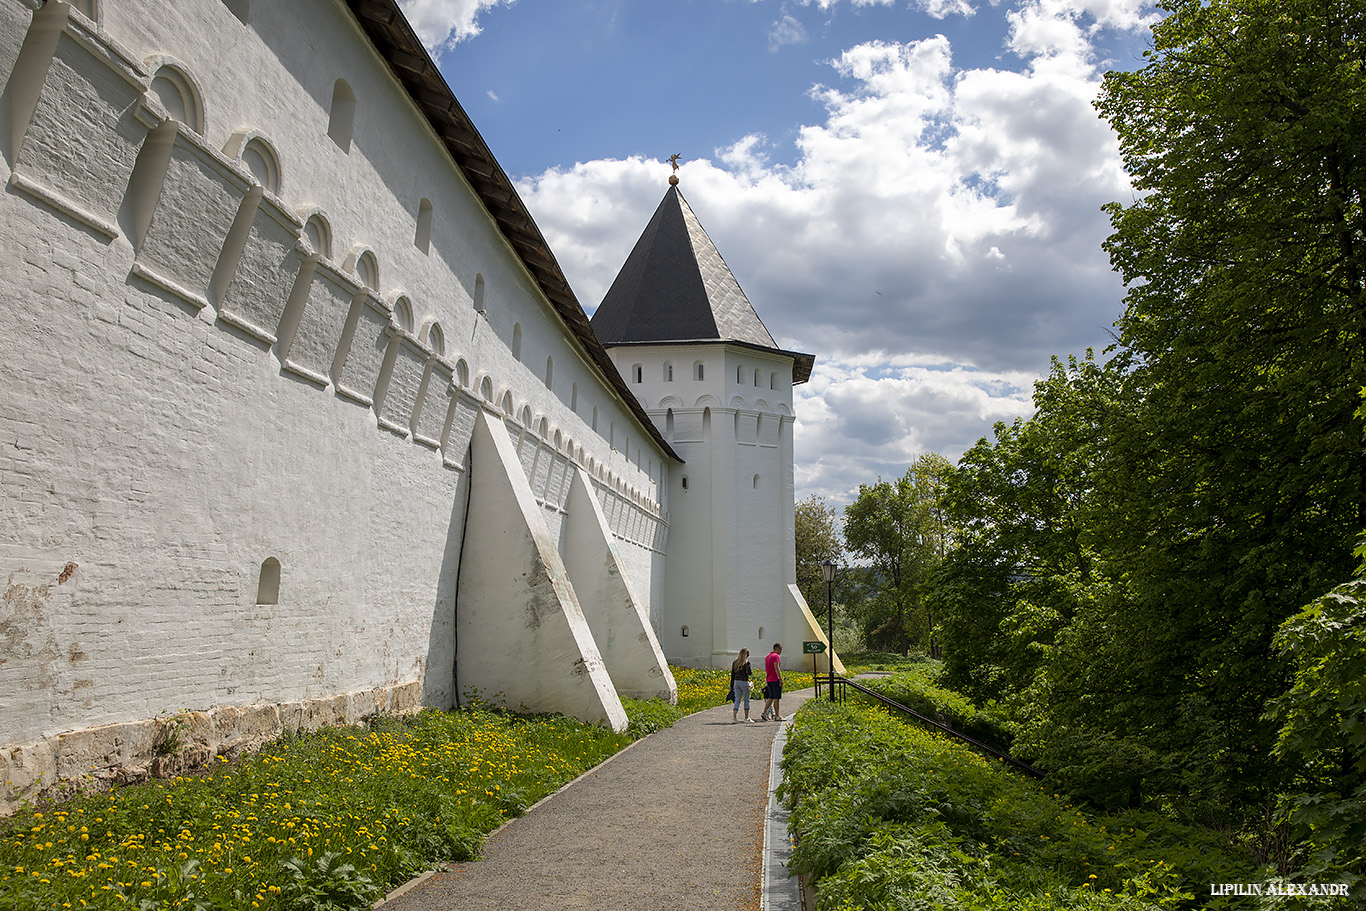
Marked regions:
[593,186,777,350]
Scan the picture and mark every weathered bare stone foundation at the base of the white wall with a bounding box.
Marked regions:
[0,680,422,815]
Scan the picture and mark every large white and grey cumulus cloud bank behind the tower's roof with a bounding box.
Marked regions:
[519,0,1145,501]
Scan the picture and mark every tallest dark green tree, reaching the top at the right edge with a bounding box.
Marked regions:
[1098,0,1366,799]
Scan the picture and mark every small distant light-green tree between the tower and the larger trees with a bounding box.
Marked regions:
[844,452,953,654]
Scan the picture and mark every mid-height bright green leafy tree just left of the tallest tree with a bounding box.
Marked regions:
[929,352,1123,699]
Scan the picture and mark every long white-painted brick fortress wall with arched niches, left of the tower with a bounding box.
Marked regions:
[0,0,669,814]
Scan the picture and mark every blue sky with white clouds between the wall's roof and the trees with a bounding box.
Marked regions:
[402,0,1153,504]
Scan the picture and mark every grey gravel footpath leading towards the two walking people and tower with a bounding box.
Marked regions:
[382,694,805,911]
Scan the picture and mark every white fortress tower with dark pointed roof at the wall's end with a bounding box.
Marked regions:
[593,178,825,667]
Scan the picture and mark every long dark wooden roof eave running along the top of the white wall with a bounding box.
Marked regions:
[346,0,683,462]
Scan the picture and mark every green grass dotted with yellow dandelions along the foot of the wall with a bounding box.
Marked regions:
[0,699,680,911]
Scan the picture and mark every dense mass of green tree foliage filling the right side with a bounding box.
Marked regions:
[930,0,1366,809]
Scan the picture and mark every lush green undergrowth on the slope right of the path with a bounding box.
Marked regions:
[783,702,1311,911]
